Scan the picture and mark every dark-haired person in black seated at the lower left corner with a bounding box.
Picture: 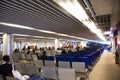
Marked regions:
[0,55,13,80]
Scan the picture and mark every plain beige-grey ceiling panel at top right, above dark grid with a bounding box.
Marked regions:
[89,0,114,16]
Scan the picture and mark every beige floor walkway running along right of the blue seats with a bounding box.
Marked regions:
[89,52,120,80]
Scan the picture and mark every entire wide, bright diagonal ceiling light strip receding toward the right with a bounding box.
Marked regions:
[53,0,105,41]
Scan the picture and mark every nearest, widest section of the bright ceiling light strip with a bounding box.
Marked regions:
[54,0,89,21]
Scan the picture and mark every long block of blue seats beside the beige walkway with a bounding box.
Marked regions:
[48,48,104,68]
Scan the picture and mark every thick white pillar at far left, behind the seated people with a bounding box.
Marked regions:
[3,34,13,55]
